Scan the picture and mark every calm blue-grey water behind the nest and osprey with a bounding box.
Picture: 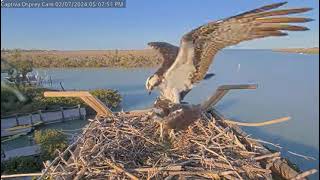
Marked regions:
[2,50,319,179]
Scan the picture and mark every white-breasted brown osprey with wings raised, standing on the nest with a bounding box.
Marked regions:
[146,2,312,104]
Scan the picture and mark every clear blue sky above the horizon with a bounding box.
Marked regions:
[1,0,319,50]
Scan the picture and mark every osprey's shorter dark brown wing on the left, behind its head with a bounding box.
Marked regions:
[148,42,179,76]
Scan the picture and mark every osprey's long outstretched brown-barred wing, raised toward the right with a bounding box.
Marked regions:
[182,3,312,83]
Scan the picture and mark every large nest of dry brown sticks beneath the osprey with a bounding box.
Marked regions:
[46,113,278,179]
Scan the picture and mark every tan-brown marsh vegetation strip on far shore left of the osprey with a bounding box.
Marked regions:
[1,50,161,68]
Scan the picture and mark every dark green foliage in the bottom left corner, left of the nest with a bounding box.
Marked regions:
[1,156,42,174]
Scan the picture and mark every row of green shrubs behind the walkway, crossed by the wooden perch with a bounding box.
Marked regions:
[1,86,121,116]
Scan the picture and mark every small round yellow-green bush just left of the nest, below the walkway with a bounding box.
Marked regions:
[34,129,68,161]
